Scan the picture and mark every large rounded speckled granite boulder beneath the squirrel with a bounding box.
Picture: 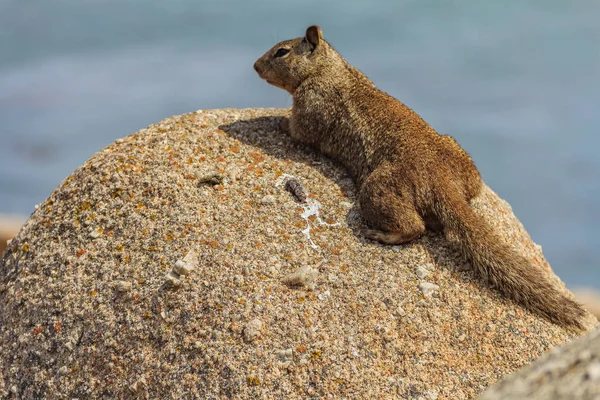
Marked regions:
[0,109,596,399]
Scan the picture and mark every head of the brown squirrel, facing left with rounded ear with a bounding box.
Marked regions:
[254,25,341,94]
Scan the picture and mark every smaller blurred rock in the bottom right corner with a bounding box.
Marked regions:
[480,329,600,400]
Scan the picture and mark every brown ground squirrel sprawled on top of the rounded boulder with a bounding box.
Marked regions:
[254,26,585,330]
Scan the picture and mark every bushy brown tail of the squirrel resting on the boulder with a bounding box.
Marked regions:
[434,191,586,331]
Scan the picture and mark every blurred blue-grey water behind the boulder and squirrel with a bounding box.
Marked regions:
[0,0,600,288]
